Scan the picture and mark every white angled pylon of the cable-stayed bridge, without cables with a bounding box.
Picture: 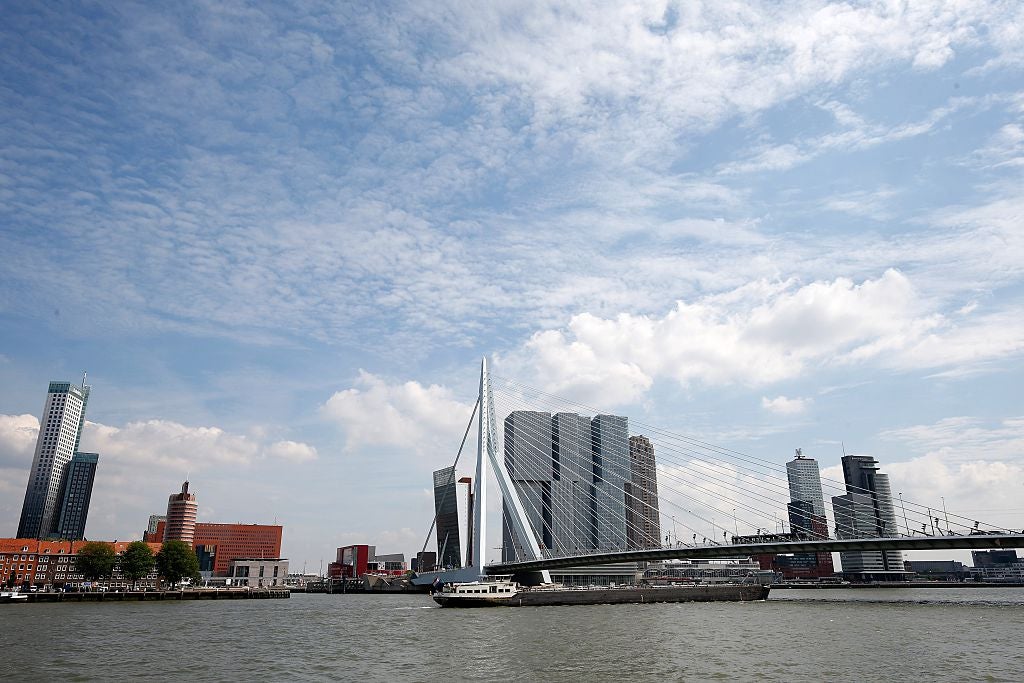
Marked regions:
[472,357,551,584]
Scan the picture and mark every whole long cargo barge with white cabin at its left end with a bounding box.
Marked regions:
[431,580,770,607]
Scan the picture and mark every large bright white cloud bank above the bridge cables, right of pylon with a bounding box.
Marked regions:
[497,270,1024,405]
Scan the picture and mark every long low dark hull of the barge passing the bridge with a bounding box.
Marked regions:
[433,584,770,607]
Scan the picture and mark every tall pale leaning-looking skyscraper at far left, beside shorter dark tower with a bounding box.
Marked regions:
[17,379,90,539]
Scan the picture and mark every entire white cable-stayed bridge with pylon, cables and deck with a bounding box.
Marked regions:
[415,358,1024,584]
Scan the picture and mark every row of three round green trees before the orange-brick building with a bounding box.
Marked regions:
[76,541,199,588]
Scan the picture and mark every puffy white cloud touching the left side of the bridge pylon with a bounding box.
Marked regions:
[322,370,473,454]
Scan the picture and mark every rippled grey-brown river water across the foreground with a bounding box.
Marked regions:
[0,589,1024,681]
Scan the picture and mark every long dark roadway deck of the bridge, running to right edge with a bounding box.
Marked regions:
[483,533,1024,575]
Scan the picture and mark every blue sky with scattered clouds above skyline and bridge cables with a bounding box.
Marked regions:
[0,0,1024,571]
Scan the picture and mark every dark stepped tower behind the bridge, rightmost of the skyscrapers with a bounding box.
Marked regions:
[833,456,903,573]
